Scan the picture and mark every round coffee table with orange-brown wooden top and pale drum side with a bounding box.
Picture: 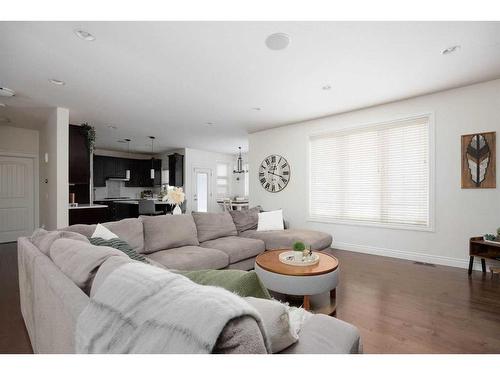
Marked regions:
[255,249,339,314]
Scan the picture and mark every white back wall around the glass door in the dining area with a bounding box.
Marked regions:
[184,148,244,212]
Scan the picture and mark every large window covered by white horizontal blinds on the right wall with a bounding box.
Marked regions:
[309,116,430,229]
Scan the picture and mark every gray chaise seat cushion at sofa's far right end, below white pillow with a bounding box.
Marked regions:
[240,229,332,250]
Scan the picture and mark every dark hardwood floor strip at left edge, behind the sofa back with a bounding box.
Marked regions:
[0,242,33,354]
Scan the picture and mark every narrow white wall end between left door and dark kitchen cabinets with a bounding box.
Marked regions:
[40,108,69,230]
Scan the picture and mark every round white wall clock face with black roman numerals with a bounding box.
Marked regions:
[259,155,290,193]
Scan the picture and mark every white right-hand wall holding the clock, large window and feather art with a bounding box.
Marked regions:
[249,80,500,267]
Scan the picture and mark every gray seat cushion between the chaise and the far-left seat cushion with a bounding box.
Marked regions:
[200,236,266,264]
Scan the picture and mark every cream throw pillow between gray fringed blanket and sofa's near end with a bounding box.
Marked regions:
[245,297,299,353]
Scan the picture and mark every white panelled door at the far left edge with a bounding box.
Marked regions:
[0,156,35,243]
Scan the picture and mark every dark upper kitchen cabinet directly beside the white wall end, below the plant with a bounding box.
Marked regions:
[69,125,90,184]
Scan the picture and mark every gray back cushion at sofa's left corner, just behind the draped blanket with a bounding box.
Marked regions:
[50,238,127,294]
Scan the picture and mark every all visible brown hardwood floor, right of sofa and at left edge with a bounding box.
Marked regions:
[0,243,500,353]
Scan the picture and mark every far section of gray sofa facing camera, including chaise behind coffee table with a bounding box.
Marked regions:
[64,212,332,270]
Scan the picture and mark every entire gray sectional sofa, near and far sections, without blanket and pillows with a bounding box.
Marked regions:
[18,213,361,354]
